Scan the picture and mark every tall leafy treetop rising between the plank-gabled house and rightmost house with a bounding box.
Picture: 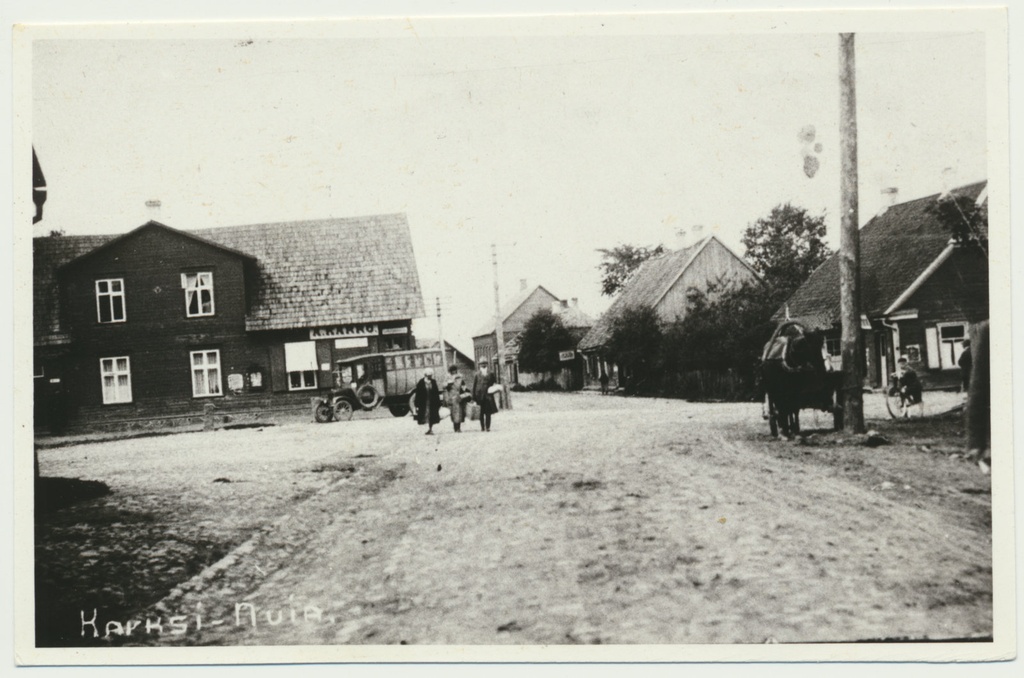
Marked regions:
[742,203,831,301]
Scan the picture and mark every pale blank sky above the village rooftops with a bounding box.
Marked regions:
[32,19,986,353]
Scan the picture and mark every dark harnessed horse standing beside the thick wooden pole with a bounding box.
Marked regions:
[761,321,839,438]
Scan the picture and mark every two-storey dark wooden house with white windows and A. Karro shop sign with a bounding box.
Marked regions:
[33,214,424,426]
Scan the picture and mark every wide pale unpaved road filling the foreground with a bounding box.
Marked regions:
[40,394,992,644]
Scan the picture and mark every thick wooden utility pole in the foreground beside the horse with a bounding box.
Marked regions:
[839,33,864,433]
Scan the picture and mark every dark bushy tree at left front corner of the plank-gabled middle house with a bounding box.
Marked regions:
[607,305,663,392]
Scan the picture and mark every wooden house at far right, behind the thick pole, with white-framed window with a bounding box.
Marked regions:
[774,181,988,389]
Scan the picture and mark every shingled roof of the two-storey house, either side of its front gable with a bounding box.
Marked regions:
[33,214,425,343]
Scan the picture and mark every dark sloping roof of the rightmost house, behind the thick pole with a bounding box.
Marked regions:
[773,181,986,329]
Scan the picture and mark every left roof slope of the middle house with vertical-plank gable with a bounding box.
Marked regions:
[580,236,741,350]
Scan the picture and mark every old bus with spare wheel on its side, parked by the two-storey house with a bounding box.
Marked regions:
[313,348,456,423]
